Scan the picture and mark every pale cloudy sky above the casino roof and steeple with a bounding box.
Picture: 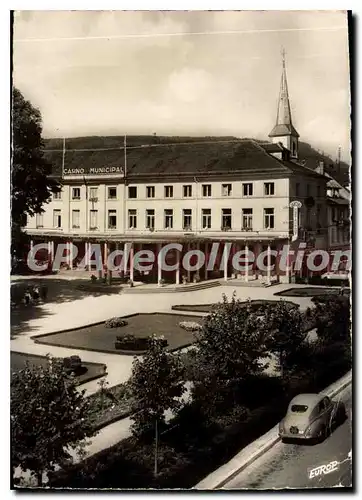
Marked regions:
[13,11,350,162]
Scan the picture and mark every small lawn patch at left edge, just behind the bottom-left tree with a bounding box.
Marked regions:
[10,352,106,385]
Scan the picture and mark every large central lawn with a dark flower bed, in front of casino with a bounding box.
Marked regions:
[32,313,202,354]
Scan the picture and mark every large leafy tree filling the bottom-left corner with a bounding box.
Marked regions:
[11,358,94,486]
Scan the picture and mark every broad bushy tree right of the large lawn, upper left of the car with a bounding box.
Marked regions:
[193,294,268,413]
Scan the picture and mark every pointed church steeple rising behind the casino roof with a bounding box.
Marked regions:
[269,49,299,158]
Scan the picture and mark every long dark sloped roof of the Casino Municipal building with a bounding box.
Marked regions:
[45,136,326,179]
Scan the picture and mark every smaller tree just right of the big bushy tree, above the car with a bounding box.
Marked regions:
[262,300,307,376]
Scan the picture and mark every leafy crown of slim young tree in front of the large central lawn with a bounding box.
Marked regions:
[128,335,185,438]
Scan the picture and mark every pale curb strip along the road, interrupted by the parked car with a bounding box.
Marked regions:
[192,371,352,490]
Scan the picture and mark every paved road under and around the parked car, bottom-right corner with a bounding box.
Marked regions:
[223,385,352,490]
